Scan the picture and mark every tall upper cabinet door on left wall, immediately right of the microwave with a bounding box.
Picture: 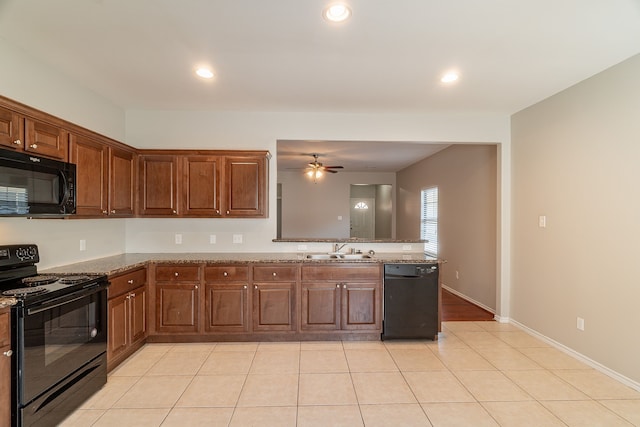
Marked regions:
[69,135,108,216]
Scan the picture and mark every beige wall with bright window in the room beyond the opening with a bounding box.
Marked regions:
[397,145,497,310]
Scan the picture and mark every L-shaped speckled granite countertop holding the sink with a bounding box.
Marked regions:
[39,252,438,275]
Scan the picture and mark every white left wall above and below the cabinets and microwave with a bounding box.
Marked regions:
[0,39,125,268]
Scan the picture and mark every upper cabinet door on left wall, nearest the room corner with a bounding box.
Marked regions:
[109,148,135,216]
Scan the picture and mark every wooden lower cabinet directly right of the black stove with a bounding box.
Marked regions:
[107,269,148,370]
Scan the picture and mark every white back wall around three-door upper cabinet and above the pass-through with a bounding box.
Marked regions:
[126,111,509,252]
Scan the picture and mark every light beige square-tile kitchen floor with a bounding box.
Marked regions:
[63,322,640,427]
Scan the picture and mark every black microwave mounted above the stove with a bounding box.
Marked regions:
[0,149,76,216]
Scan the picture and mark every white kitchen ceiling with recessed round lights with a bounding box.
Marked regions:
[0,0,640,171]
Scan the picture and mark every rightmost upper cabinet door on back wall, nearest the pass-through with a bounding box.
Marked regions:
[224,156,267,218]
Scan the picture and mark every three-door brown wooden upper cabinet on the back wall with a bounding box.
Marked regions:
[139,150,268,218]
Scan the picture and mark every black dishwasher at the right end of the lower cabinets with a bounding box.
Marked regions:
[381,264,438,340]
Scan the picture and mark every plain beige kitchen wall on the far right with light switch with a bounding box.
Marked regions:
[511,55,640,382]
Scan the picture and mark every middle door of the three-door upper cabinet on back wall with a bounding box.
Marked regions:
[182,156,221,217]
